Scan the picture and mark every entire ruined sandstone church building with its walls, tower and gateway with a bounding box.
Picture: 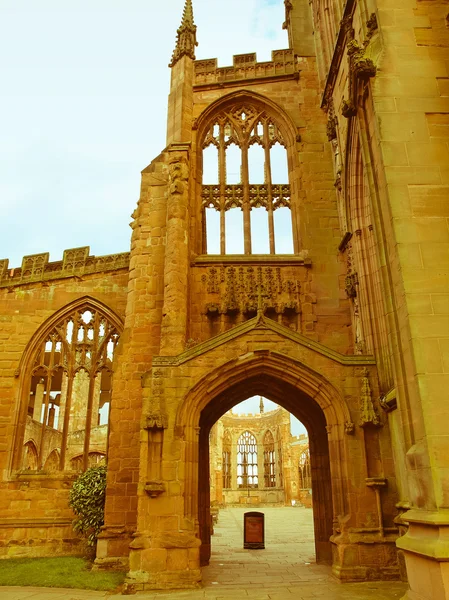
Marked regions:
[0,0,449,600]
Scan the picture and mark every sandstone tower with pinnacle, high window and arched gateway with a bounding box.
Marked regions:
[97,0,398,589]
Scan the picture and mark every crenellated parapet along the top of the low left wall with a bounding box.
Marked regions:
[0,246,129,287]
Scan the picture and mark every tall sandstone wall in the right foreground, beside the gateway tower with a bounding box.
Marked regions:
[313,0,449,598]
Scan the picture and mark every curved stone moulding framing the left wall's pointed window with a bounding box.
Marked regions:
[9,295,124,472]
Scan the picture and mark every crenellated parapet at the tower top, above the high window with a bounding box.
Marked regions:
[194,49,298,85]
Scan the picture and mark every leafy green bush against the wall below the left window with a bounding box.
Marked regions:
[69,465,106,546]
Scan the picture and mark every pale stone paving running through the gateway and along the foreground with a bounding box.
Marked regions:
[0,508,407,600]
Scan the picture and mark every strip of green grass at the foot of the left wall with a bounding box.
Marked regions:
[0,556,125,595]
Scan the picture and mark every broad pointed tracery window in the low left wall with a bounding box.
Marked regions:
[16,301,119,472]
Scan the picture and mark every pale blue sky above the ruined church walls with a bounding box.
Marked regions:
[0,0,288,267]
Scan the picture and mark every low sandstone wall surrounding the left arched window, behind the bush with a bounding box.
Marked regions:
[0,249,128,556]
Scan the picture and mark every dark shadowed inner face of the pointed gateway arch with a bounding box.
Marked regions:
[198,372,334,566]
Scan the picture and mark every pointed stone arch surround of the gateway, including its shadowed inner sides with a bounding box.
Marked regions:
[176,350,350,565]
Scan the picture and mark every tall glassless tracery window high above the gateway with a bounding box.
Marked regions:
[202,104,293,254]
